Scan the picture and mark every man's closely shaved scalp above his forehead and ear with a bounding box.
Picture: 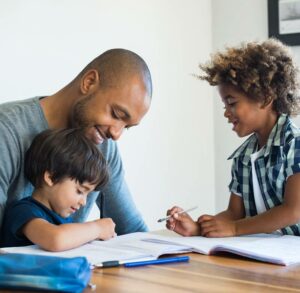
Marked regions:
[78,49,152,98]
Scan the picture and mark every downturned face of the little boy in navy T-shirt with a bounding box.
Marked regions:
[47,178,96,218]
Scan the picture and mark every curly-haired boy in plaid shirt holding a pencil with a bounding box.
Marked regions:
[167,39,300,237]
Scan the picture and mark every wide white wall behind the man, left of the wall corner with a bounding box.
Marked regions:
[0,0,215,229]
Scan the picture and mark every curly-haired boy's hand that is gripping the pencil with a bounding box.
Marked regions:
[166,206,200,236]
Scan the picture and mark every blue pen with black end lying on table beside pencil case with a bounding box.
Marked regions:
[94,256,190,268]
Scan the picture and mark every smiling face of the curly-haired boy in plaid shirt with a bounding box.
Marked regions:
[218,84,274,137]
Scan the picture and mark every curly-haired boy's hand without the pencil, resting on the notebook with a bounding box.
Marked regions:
[197,215,236,237]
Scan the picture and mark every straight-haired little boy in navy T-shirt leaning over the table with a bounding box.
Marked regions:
[1,129,115,251]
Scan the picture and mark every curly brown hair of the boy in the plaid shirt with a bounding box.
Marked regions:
[197,38,300,115]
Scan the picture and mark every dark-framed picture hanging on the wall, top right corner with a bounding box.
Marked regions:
[268,0,300,46]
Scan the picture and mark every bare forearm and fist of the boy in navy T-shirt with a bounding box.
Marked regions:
[22,218,115,251]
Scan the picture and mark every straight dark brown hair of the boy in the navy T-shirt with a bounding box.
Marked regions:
[24,129,109,190]
